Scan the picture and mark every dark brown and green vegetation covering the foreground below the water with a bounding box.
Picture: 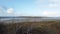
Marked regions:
[0,21,60,34]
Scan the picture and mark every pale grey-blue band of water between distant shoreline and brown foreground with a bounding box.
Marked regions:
[0,18,60,23]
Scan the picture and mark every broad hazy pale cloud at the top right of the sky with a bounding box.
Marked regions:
[35,0,60,8]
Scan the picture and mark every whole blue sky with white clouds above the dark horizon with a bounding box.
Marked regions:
[0,0,60,17]
